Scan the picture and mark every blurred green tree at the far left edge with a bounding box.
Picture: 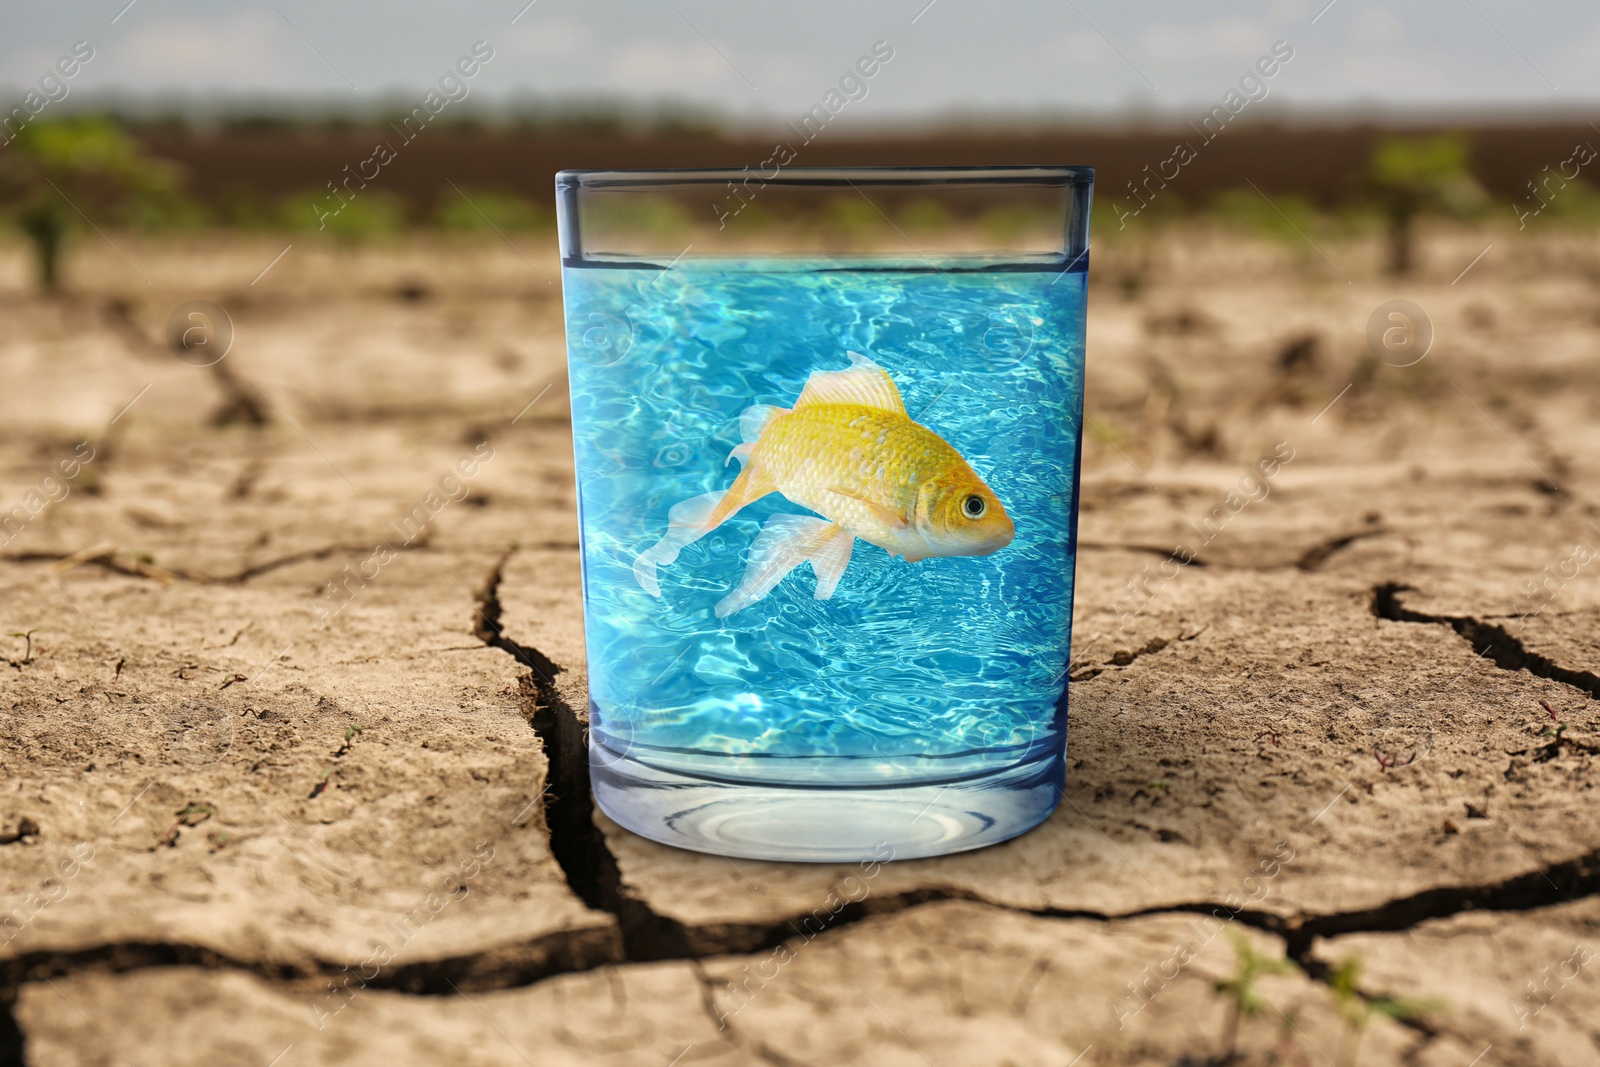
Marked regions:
[0,117,176,291]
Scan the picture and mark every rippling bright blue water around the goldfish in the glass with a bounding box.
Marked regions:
[563,258,1086,863]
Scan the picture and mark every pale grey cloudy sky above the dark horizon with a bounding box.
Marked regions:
[0,0,1600,126]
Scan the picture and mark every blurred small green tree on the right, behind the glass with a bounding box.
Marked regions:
[1366,133,1485,275]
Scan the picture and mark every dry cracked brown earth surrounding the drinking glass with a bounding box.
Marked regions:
[0,220,1600,1067]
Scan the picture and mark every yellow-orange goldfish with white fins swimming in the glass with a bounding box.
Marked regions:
[634,352,1016,617]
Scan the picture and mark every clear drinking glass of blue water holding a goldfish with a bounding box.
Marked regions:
[555,168,1093,861]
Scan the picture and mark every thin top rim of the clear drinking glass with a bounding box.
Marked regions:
[555,165,1094,190]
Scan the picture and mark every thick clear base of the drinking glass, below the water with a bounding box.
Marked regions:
[589,745,1066,864]
